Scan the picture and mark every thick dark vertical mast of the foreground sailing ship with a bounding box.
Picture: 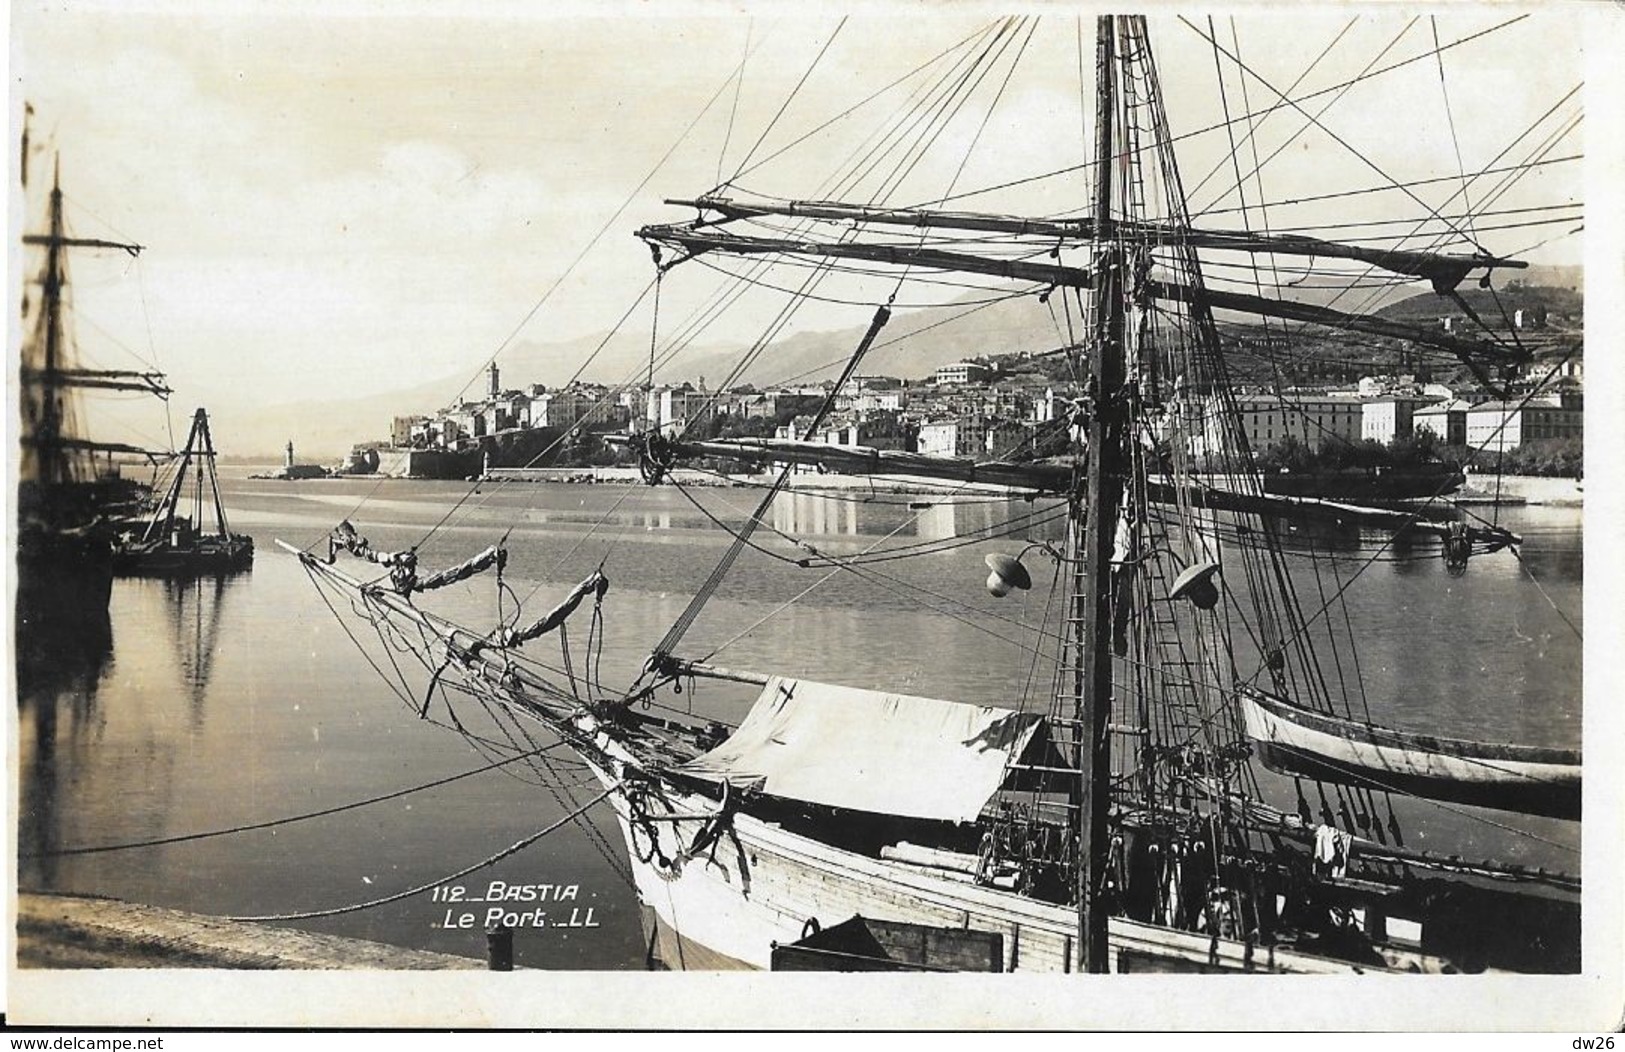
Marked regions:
[1068,15,1126,972]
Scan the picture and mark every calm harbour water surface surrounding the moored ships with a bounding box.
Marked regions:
[20,478,1583,969]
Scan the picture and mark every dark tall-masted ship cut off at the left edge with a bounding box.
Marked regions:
[16,138,169,676]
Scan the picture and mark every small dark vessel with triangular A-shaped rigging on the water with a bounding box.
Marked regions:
[114,408,254,577]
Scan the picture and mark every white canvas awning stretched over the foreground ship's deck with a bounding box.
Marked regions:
[678,676,1043,821]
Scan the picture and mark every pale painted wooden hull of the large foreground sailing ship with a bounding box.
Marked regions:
[595,754,1446,974]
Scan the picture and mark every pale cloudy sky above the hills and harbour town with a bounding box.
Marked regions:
[10,0,1607,452]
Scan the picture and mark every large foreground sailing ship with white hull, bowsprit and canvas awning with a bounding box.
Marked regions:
[283,16,1580,974]
